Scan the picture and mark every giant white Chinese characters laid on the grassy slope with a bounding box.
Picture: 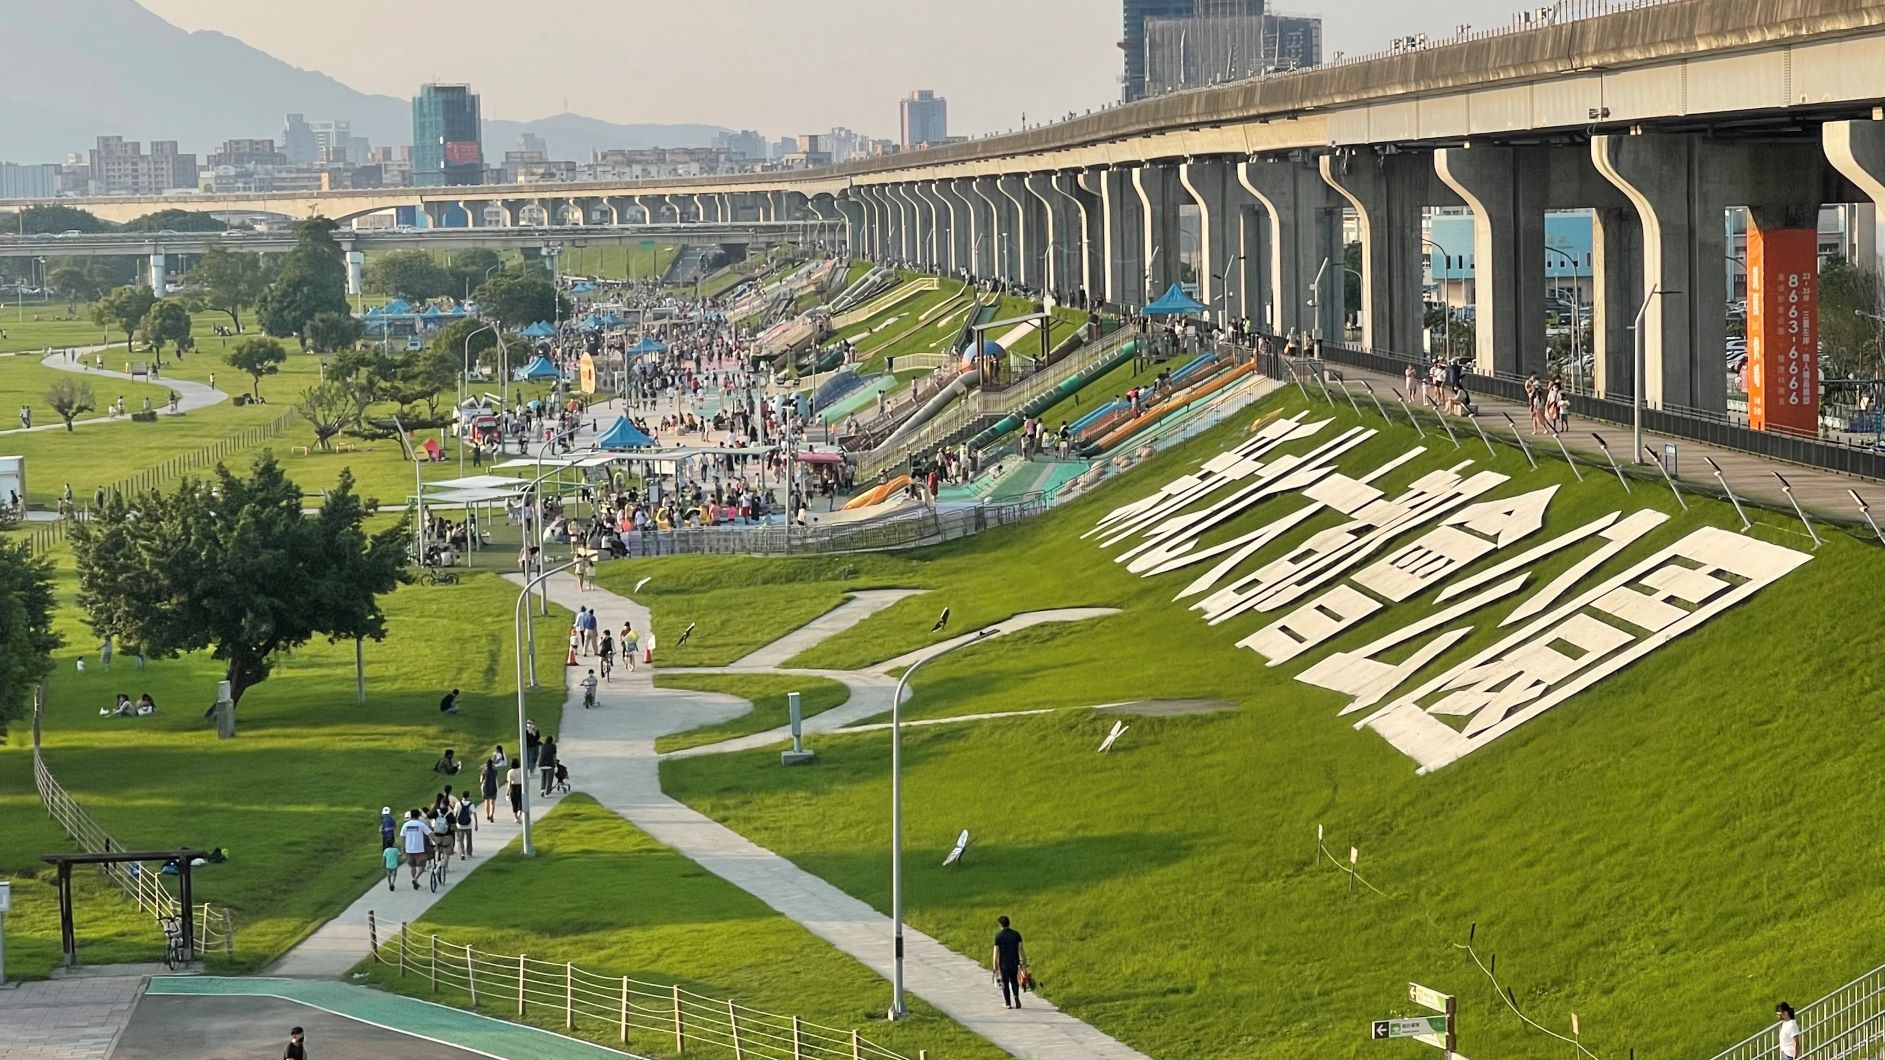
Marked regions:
[1088,415,1811,771]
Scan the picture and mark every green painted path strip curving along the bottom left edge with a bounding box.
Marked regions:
[145,975,648,1060]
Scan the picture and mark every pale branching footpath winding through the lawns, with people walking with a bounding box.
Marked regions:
[270,573,1144,1060]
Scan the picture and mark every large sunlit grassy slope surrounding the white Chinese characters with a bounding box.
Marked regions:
[654,398,1885,1058]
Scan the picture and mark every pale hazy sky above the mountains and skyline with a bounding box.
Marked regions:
[143,0,1521,138]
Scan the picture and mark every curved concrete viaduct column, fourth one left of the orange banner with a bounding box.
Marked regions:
[1237,160,1344,336]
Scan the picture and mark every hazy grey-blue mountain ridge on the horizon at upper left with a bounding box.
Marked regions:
[0,0,722,162]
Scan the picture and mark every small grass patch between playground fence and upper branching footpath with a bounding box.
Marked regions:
[596,556,861,666]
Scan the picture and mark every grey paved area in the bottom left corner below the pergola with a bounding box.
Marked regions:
[0,975,143,1060]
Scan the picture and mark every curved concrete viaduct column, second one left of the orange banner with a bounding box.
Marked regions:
[1433,145,1551,375]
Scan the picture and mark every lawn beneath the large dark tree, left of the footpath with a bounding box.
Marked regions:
[0,558,564,975]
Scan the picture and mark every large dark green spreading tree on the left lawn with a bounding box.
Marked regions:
[72,453,407,704]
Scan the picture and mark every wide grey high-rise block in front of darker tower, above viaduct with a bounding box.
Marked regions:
[1144,10,1321,96]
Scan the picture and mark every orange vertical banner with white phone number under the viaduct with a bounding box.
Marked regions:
[1747,223,1819,434]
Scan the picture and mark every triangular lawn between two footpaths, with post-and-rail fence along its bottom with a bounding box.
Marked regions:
[364,796,1003,1060]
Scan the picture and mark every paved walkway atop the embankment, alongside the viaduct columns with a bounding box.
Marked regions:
[1308,360,1885,521]
